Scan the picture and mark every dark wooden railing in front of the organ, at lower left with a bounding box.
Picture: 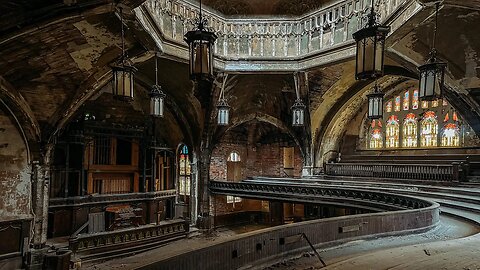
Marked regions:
[69,219,189,255]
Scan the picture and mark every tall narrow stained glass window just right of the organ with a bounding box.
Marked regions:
[178,145,192,203]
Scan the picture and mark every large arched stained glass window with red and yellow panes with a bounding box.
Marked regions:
[364,89,468,149]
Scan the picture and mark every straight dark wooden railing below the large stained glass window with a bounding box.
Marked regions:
[325,162,462,181]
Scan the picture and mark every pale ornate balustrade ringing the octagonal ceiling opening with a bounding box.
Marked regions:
[135,0,420,70]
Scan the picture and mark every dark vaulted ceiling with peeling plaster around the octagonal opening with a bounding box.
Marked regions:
[0,0,480,160]
